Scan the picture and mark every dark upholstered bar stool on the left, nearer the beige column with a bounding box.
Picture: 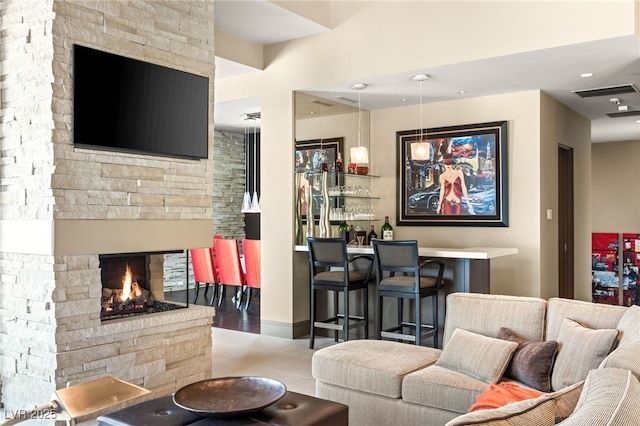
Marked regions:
[307,237,373,349]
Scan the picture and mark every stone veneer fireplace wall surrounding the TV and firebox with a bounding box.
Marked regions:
[0,0,215,410]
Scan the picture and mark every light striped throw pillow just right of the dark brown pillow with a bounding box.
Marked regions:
[551,318,618,390]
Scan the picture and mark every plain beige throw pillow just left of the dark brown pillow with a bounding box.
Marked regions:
[436,328,518,383]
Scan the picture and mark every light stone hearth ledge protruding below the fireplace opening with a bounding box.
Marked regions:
[58,305,215,397]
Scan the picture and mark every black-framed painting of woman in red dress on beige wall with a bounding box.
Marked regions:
[396,121,509,227]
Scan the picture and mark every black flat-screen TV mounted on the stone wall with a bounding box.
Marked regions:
[73,45,209,158]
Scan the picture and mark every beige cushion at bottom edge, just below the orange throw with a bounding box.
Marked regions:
[446,382,583,426]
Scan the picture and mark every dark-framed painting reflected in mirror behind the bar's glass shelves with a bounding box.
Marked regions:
[294,137,344,222]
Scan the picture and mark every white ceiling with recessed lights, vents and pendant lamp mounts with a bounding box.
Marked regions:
[215,0,640,142]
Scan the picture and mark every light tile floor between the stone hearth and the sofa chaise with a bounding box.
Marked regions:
[73,327,334,426]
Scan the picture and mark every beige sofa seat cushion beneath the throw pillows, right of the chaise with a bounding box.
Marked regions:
[402,365,489,414]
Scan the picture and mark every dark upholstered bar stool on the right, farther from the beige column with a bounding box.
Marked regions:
[373,240,444,348]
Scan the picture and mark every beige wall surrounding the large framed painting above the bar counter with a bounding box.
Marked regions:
[370,91,540,296]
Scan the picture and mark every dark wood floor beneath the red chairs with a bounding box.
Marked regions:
[164,285,260,334]
